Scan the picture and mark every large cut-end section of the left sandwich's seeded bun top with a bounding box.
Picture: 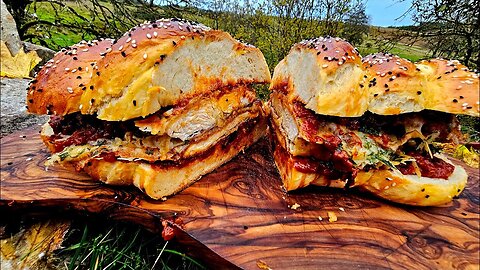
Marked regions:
[28,19,270,121]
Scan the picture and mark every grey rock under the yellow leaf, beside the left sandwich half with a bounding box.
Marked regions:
[0,78,48,137]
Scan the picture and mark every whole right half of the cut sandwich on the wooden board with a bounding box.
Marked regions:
[269,37,479,206]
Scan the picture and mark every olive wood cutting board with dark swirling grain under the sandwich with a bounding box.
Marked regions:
[0,129,480,269]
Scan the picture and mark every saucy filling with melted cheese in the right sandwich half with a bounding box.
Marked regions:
[271,93,461,186]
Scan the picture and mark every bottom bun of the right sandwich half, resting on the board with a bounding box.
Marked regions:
[274,142,468,206]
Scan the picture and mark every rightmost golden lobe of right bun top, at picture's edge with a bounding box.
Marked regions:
[416,59,480,117]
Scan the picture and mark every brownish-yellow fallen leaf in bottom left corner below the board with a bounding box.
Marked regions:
[0,221,70,270]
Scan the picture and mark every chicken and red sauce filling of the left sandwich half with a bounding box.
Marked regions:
[42,86,262,165]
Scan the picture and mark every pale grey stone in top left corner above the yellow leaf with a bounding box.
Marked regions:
[0,0,23,56]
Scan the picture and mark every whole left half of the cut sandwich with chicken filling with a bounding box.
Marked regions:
[27,19,271,199]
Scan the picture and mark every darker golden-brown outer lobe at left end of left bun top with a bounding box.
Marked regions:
[27,39,114,115]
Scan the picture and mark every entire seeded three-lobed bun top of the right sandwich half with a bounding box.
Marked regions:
[270,37,480,117]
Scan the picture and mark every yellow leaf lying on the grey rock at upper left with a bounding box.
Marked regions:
[0,41,42,78]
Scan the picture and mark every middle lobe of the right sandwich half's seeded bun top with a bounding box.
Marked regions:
[362,53,425,115]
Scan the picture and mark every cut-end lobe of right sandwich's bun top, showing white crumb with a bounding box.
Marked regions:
[270,37,368,117]
